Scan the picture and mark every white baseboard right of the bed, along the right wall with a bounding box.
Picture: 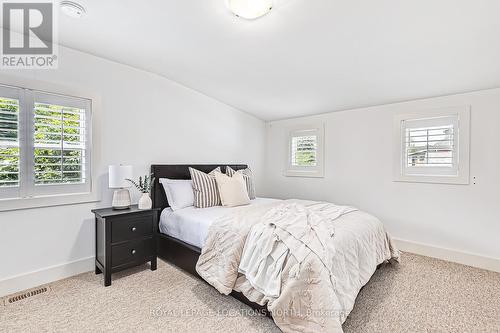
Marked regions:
[394,239,500,273]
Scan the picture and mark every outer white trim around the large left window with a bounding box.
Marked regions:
[0,76,101,212]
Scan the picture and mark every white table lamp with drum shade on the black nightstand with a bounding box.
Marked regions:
[108,165,133,209]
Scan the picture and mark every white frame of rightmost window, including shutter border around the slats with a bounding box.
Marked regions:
[393,106,471,185]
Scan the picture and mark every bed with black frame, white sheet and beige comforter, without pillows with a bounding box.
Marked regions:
[151,165,399,332]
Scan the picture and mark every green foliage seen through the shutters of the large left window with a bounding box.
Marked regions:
[0,98,85,186]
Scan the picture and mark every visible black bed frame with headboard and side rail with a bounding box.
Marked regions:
[151,164,271,316]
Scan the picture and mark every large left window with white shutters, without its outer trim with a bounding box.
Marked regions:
[0,86,91,198]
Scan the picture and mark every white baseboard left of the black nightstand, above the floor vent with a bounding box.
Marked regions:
[0,256,95,297]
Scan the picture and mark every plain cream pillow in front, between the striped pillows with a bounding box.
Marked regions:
[215,172,250,207]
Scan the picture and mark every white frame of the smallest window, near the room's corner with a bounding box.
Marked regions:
[284,123,325,178]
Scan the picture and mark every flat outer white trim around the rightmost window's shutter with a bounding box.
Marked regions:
[393,105,471,185]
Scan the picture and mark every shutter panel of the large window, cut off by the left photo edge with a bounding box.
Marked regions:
[0,86,22,198]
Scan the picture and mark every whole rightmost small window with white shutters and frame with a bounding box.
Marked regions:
[395,108,470,183]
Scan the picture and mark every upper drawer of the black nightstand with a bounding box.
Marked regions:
[111,216,153,243]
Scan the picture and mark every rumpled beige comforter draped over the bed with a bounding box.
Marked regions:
[196,200,399,332]
